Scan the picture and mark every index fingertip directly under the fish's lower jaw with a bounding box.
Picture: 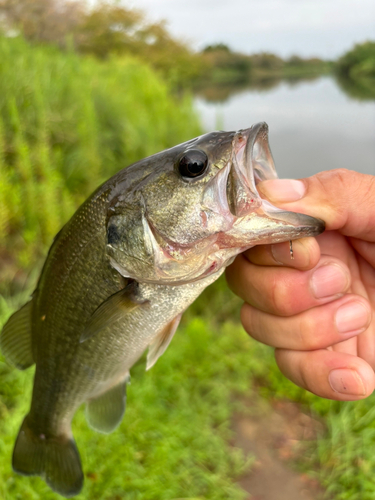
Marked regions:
[244,238,320,270]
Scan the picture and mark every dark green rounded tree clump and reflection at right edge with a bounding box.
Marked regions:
[335,41,375,99]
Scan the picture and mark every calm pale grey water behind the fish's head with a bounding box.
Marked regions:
[195,77,375,178]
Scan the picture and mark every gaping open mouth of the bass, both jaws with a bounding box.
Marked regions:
[207,122,325,246]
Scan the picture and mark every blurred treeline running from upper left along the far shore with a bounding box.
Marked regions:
[0,0,330,86]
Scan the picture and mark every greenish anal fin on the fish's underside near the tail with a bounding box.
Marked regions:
[86,375,130,434]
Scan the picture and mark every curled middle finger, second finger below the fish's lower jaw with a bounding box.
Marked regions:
[226,255,350,316]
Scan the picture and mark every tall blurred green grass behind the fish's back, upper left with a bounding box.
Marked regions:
[0,37,200,266]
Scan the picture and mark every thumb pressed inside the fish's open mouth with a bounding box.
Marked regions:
[257,169,375,242]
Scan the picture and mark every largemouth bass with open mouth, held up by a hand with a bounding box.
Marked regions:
[0,123,324,497]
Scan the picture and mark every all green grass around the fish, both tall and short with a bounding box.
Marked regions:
[0,37,375,500]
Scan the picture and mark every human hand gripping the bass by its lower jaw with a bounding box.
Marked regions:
[227,169,375,401]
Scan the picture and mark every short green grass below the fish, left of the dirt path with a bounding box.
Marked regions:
[0,288,258,500]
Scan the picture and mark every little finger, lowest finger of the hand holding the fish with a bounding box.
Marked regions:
[275,349,375,401]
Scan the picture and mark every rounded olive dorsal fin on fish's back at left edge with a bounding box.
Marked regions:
[0,301,34,370]
